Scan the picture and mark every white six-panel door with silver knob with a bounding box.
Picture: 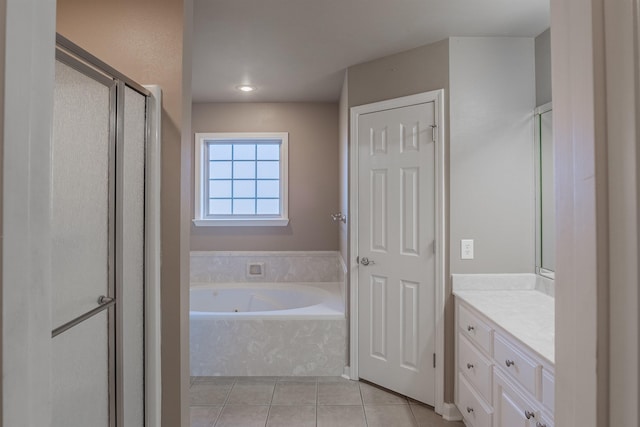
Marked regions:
[357,102,435,405]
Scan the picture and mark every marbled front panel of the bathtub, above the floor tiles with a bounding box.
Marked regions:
[190,318,347,376]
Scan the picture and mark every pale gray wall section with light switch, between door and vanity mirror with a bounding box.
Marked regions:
[449,37,535,273]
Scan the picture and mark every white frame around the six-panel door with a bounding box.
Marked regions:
[349,89,446,414]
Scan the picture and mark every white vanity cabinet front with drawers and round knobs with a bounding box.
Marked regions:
[455,298,554,427]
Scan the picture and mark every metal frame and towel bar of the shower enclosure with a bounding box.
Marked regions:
[52,34,161,427]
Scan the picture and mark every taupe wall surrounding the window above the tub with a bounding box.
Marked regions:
[191,103,339,251]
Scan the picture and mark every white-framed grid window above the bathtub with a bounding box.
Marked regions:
[193,132,289,226]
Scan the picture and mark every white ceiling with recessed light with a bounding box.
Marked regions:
[193,0,549,102]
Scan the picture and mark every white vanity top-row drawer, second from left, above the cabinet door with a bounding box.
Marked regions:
[493,334,542,396]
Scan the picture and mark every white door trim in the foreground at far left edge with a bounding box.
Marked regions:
[0,0,56,426]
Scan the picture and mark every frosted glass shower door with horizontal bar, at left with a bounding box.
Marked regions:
[51,54,116,427]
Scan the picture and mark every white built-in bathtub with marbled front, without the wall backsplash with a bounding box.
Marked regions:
[190,283,347,376]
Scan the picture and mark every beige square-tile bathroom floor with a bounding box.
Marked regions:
[190,377,464,427]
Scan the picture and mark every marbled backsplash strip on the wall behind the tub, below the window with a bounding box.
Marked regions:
[191,251,344,283]
